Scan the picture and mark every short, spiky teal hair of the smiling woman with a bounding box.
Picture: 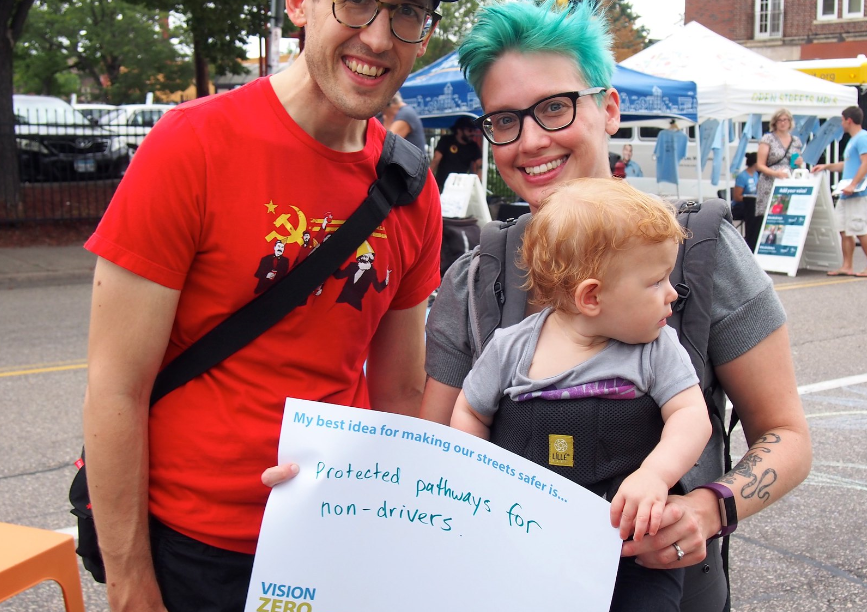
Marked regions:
[458,0,615,98]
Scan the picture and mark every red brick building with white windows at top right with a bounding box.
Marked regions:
[683,0,867,61]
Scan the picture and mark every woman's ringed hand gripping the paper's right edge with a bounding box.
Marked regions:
[620,489,720,569]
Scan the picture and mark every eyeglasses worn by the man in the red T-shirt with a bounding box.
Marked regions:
[331,0,442,43]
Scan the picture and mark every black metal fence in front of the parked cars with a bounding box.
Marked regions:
[0,104,151,225]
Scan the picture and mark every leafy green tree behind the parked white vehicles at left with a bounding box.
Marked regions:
[15,0,192,104]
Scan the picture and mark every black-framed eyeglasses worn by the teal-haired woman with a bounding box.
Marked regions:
[475,87,606,145]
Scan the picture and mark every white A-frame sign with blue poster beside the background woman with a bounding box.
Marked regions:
[755,172,840,276]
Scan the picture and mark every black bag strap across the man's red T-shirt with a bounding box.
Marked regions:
[151,132,427,405]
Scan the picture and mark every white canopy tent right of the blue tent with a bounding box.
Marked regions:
[622,21,858,198]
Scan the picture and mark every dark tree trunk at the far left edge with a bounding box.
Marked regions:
[0,0,33,207]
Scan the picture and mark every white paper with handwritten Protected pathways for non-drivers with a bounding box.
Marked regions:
[245,399,621,612]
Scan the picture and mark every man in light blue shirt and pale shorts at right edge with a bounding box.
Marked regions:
[813,106,867,278]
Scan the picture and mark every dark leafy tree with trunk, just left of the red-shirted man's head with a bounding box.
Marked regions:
[137,0,272,97]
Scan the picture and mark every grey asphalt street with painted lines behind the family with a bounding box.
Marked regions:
[0,251,867,612]
